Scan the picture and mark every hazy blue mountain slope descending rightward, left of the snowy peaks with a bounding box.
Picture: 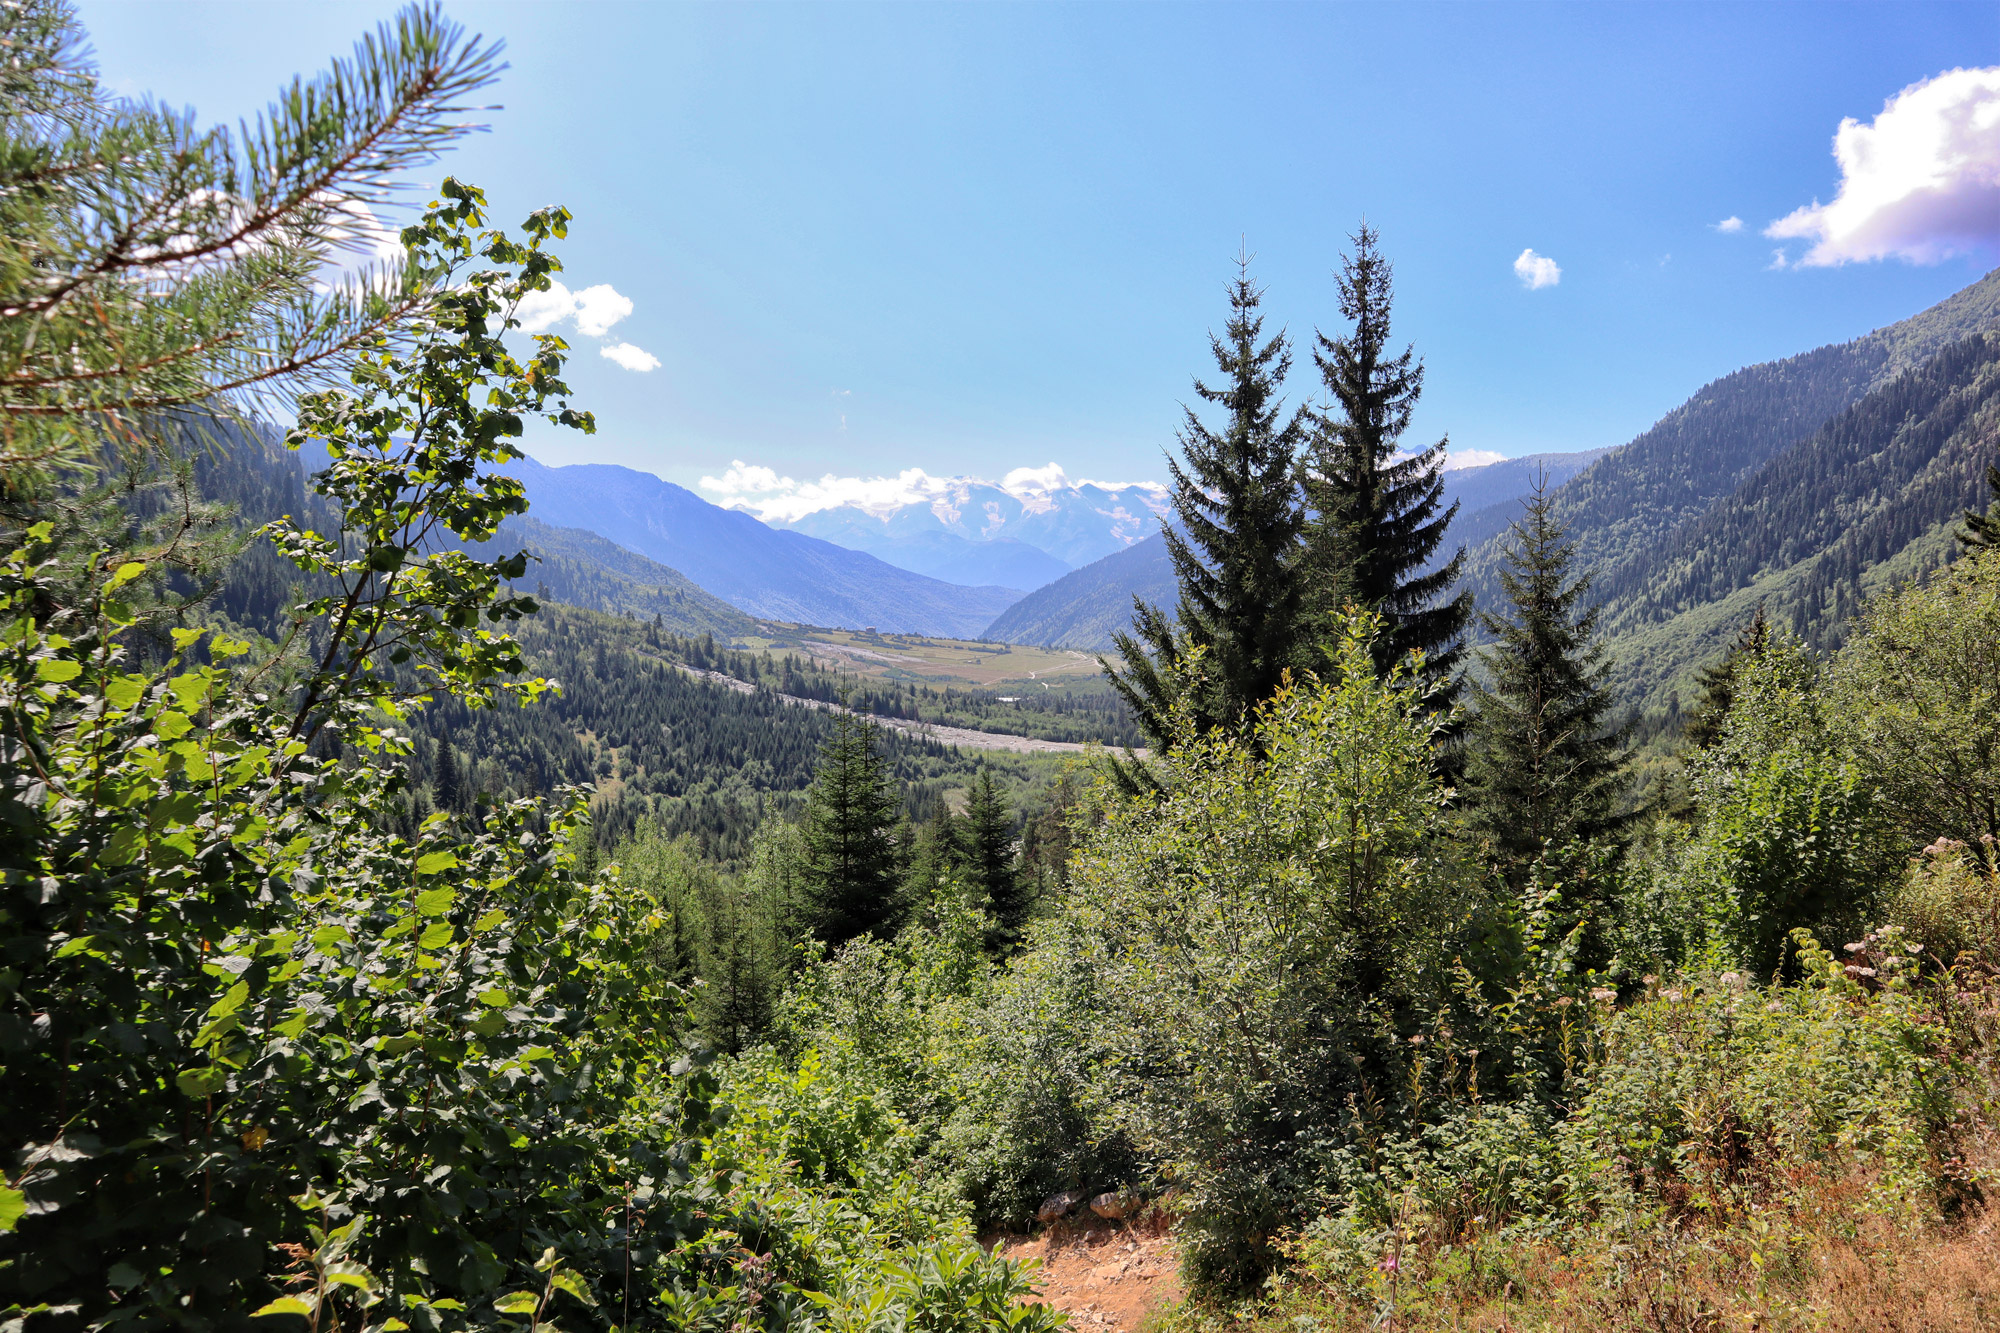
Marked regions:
[508,458,1020,636]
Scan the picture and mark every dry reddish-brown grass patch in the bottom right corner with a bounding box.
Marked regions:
[1162,969,2000,1333]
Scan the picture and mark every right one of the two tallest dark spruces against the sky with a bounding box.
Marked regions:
[1300,222,1472,684]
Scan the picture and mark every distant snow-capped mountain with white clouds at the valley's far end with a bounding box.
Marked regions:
[702,462,1166,590]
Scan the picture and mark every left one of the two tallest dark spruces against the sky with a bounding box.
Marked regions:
[1102,256,1304,749]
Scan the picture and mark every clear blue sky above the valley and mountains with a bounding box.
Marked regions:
[82,0,2000,500]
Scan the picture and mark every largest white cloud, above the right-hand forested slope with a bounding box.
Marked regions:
[1764,66,2000,268]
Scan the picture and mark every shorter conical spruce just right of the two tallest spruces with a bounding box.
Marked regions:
[1466,482,1628,873]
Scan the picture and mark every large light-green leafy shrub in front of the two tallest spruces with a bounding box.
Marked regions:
[1066,614,1468,1289]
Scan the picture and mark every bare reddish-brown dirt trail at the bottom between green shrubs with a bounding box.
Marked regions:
[1000,1217,1182,1333]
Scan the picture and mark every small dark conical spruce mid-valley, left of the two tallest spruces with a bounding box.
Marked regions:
[800,713,902,949]
